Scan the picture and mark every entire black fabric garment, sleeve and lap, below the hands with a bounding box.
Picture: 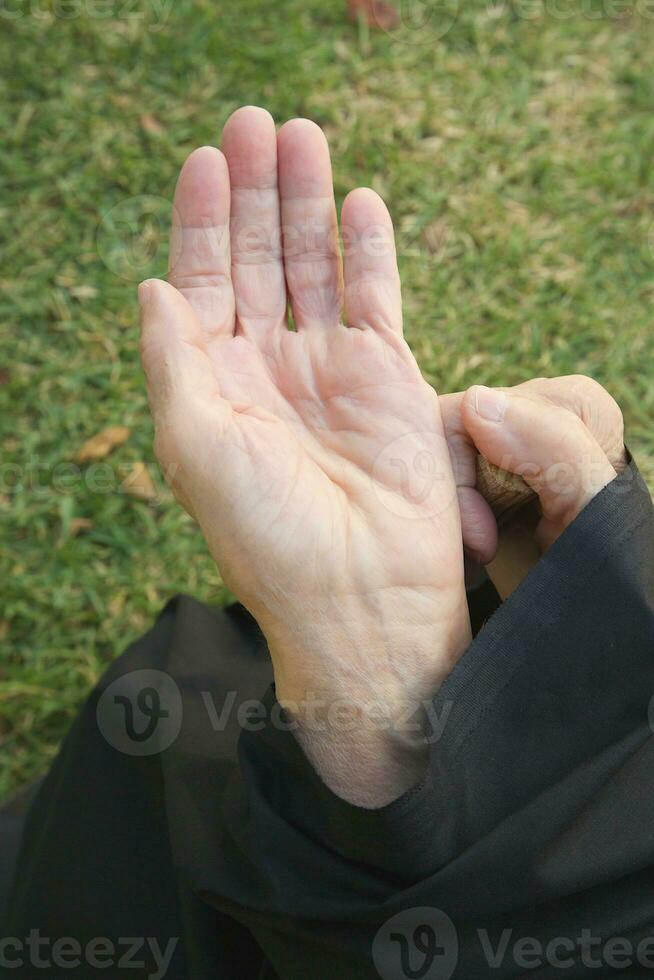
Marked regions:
[5,464,654,980]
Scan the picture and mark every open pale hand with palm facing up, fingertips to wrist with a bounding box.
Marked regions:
[140,107,615,807]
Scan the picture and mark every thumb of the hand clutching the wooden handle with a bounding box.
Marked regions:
[461,385,616,547]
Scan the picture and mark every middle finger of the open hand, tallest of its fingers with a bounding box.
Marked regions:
[222,106,286,342]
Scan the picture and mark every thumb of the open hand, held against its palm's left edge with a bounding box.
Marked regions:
[139,279,227,425]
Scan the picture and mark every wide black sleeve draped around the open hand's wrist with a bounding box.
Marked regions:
[203,463,654,980]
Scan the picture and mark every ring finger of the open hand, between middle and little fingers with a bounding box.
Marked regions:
[277,119,343,330]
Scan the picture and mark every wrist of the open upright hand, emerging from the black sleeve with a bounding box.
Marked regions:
[264,592,471,807]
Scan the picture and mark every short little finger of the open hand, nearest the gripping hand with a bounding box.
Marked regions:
[341,187,402,334]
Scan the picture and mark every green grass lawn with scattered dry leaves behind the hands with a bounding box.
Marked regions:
[0,0,654,798]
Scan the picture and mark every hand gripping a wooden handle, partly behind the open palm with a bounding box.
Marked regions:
[441,375,626,598]
